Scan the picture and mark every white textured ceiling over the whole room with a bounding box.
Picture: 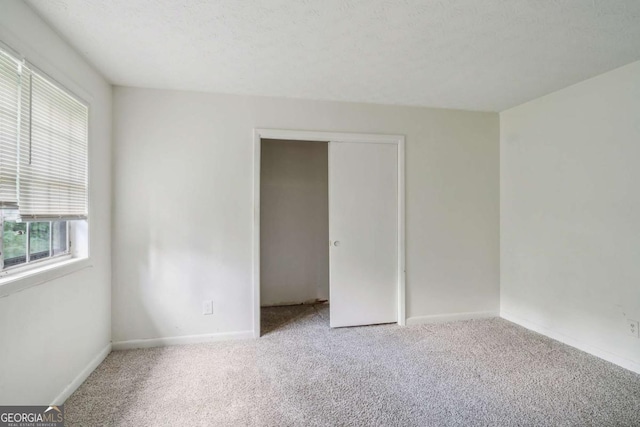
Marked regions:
[29,0,640,111]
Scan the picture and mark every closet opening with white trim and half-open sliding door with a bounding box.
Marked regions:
[253,129,406,338]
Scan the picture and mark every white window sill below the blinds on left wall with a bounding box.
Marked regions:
[0,258,93,298]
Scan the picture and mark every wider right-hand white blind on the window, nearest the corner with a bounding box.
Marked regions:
[19,72,88,219]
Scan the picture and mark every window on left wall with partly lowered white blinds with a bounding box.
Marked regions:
[0,48,89,274]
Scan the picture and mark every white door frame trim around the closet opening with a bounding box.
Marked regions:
[252,128,406,338]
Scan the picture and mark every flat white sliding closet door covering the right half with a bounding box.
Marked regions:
[329,142,398,327]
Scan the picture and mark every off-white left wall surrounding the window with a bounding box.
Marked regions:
[0,1,111,405]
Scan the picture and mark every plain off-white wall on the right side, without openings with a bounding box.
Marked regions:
[500,62,640,372]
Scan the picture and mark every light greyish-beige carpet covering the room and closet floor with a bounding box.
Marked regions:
[65,305,640,426]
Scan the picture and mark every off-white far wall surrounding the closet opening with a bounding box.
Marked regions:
[112,87,499,344]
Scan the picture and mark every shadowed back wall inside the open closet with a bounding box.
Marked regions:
[260,139,329,306]
